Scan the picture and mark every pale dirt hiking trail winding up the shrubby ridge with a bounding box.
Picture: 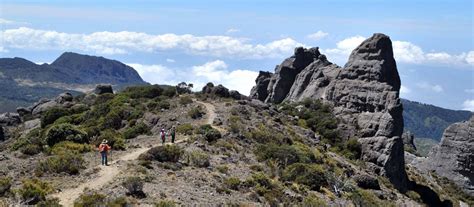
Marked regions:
[51,101,221,206]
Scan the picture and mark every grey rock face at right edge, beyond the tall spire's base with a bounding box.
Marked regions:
[414,116,474,196]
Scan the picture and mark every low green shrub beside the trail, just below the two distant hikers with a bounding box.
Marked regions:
[139,145,183,162]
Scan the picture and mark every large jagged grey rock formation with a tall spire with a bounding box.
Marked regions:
[250,34,407,190]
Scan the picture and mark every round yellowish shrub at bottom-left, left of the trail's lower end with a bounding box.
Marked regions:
[18,178,53,205]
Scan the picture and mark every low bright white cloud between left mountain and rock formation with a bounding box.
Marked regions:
[127,60,258,95]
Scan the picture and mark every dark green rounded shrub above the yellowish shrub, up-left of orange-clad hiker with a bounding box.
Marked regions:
[46,124,88,146]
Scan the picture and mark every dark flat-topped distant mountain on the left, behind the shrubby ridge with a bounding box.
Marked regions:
[0,52,148,112]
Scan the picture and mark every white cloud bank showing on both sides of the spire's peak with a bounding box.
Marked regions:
[323,35,474,66]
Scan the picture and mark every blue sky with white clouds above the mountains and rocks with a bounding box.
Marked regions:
[0,0,474,111]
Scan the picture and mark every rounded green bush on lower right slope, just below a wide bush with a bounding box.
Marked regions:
[282,163,328,190]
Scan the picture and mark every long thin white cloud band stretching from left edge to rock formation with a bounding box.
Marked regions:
[0,27,304,59]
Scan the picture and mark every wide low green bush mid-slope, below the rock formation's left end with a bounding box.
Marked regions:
[255,143,316,167]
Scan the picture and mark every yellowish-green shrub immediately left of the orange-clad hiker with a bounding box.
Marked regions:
[35,151,84,175]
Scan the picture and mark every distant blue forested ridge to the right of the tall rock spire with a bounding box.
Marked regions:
[402,99,472,142]
